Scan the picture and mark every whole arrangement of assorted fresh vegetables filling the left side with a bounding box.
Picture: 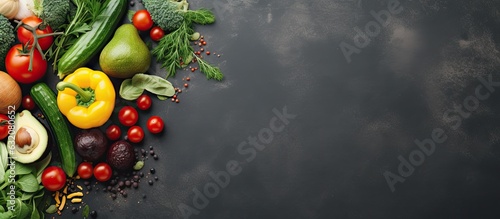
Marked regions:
[0,0,223,218]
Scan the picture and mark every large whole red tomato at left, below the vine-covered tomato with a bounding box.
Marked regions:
[5,44,47,84]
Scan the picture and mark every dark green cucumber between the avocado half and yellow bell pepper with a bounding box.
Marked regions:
[30,82,76,177]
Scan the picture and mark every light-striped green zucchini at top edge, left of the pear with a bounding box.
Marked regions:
[57,0,128,79]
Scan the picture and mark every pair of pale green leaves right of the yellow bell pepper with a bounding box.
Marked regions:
[119,74,175,100]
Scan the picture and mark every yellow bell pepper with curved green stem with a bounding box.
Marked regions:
[56,68,116,129]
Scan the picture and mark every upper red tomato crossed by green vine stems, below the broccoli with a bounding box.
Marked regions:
[17,16,54,50]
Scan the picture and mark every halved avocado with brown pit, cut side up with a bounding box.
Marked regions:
[7,110,49,163]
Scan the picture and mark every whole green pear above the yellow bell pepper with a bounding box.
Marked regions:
[99,24,151,78]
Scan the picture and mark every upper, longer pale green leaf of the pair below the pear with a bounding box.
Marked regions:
[132,74,175,97]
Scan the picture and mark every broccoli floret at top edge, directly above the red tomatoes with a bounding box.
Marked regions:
[33,0,70,31]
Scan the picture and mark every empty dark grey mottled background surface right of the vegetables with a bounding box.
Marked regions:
[51,0,500,219]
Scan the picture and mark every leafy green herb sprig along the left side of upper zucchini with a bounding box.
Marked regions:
[45,0,107,72]
